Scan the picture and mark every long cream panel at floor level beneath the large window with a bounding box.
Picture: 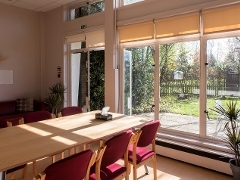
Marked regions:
[156,145,232,175]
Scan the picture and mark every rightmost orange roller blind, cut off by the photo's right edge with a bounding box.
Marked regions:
[203,4,240,34]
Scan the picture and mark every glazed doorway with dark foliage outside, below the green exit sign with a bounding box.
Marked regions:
[71,50,105,111]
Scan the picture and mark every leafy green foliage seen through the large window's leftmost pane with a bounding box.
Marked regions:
[125,46,154,113]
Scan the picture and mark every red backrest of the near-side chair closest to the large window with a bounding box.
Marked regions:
[137,120,160,147]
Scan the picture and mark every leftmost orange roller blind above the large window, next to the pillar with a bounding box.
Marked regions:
[118,22,154,42]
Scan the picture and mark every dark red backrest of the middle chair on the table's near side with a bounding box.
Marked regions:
[101,130,132,167]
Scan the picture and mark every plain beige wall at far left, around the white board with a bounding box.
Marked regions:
[0,3,41,101]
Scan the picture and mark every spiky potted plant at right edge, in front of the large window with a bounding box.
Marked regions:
[212,100,240,180]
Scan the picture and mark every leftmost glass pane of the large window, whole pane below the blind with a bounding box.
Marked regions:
[124,46,154,119]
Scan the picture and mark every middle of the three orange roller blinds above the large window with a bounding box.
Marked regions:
[155,12,200,38]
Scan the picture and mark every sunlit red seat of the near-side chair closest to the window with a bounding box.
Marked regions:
[128,145,155,164]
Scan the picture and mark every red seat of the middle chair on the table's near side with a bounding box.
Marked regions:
[90,163,127,180]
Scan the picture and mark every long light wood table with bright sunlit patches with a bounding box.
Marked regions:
[0,111,149,180]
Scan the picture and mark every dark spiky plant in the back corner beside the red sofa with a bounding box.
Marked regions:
[45,82,66,117]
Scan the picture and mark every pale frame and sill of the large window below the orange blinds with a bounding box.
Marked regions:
[119,30,240,153]
